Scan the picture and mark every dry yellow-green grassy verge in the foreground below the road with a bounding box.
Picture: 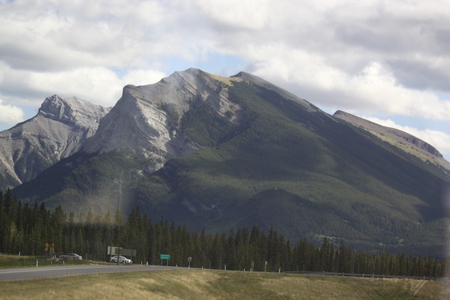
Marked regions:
[0,270,450,300]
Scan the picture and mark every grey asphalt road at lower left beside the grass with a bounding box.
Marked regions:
[0,264,180,281]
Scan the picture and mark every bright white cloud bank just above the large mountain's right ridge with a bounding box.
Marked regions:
[243,45,450,121]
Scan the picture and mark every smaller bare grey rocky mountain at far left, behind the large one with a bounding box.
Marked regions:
[0,95,109,190]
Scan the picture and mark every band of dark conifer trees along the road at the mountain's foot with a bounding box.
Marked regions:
[0,190,445,277]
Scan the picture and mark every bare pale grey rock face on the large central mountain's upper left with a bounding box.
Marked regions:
[82,69,248,171]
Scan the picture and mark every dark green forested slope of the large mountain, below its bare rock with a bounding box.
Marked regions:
[14,82,449,256]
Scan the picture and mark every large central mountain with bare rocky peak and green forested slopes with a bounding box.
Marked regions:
[13,69,450,257]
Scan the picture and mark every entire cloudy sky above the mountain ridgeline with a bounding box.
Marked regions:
[0,0,450,161]
